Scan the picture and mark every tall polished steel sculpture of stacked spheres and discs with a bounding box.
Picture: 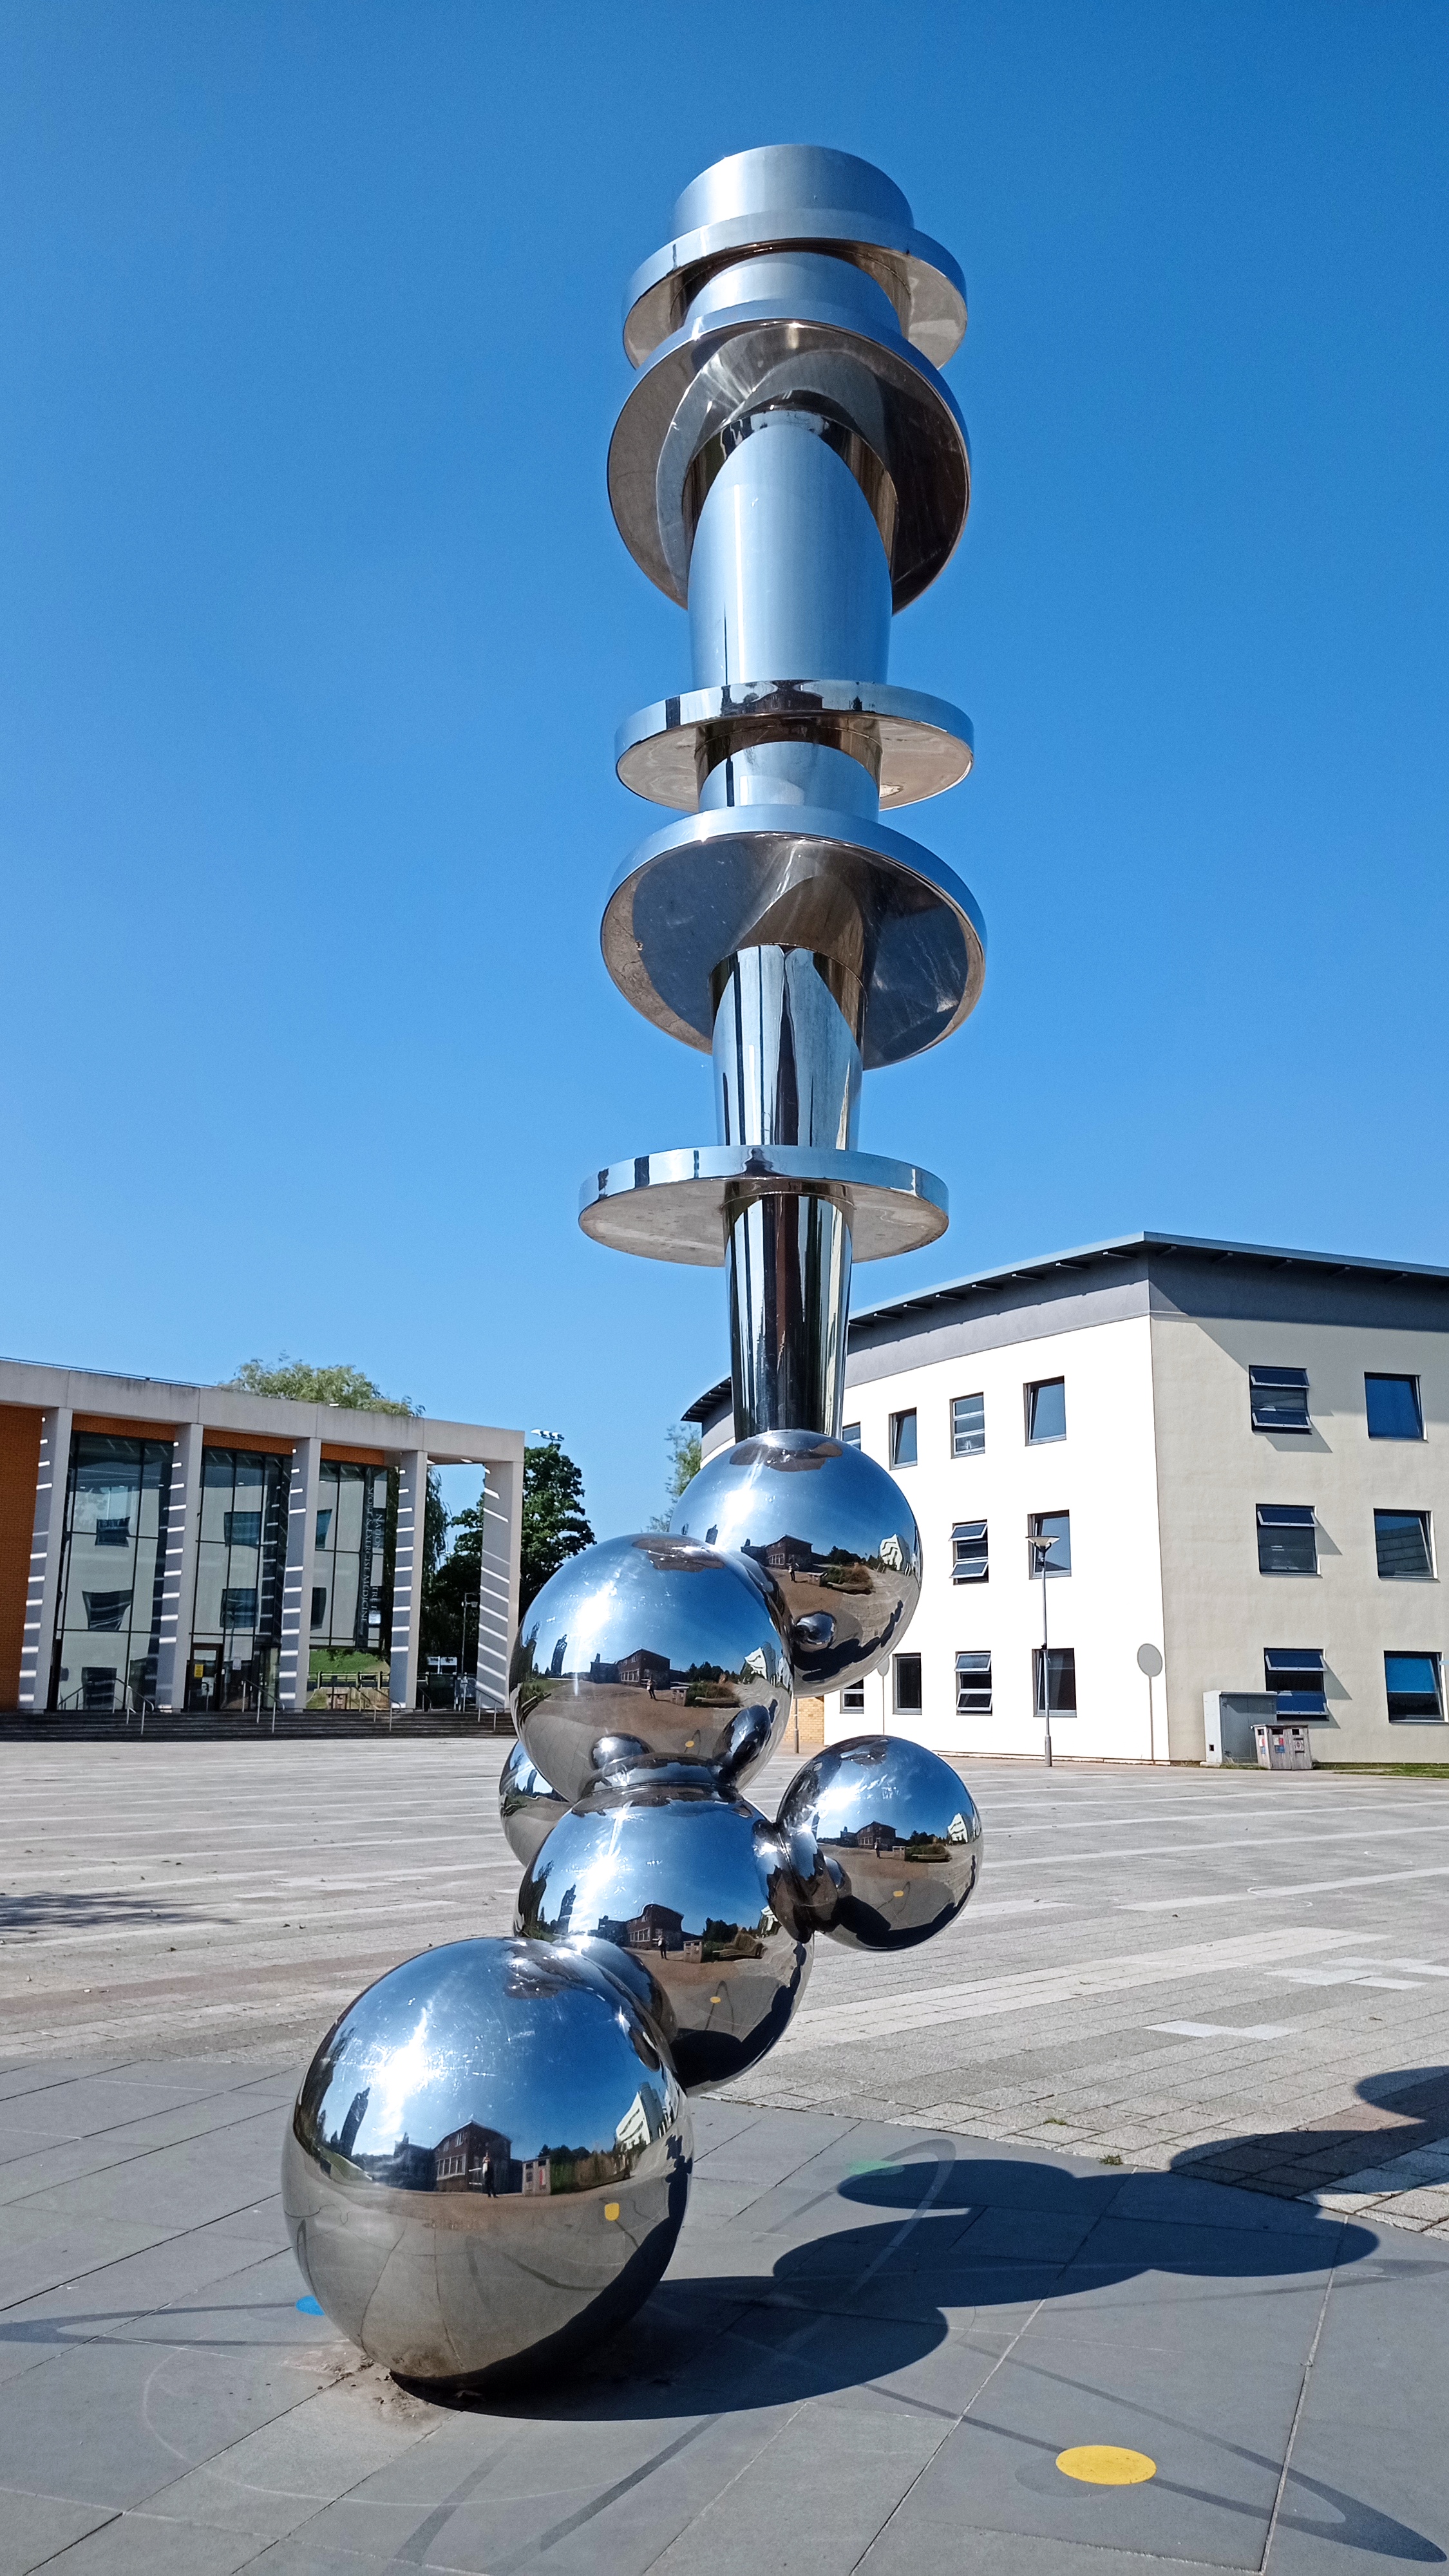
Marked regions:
[295,144,985,2383]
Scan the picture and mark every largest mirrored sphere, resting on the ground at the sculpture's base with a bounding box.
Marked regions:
[281,1940,691,2388]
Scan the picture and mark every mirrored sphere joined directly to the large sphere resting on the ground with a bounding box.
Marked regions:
[518,1785,810,2092]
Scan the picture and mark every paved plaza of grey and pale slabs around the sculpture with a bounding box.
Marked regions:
[0,1736,1449,2576]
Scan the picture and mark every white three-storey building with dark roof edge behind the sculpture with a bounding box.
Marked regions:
[691,1234,1449,1762]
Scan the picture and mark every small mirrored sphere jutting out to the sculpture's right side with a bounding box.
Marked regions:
[779,1736,982,1950]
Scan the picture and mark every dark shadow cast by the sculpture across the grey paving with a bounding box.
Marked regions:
[394,2141,1449,2576]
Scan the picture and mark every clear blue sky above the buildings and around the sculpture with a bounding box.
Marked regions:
[0,0,1449,1535]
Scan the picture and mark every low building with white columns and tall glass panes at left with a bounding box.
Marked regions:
[0,1360,524,1718]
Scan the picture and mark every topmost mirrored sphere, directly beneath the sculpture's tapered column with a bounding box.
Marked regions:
[670,1432,920,1692]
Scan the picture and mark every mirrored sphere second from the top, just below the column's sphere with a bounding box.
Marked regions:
[508,1530,791,1806]
